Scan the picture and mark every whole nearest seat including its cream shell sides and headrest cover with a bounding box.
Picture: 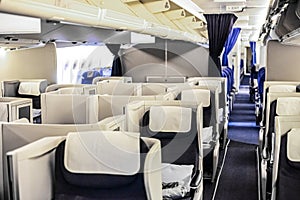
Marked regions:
[7,131,162,200]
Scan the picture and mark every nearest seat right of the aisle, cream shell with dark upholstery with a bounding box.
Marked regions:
[271,115,300,200]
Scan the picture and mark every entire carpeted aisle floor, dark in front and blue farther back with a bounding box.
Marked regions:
[204,76,259,200]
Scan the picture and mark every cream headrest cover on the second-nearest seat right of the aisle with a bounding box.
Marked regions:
[276,97,300,116]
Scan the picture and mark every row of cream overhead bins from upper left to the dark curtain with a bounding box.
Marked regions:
[0,0,207,42]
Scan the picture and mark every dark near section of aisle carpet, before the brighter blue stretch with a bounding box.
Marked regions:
[214,141,258,200]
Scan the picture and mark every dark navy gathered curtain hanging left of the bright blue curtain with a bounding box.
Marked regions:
[204,14,237,76]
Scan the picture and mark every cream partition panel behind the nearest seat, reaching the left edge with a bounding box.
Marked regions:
[0,123,111,199]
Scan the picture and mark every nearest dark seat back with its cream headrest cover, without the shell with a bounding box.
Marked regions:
[55,132,159,199]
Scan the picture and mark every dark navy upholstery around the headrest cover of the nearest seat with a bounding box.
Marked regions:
[54,140,148,200]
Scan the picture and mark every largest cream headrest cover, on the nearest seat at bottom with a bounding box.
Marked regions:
[64,131,140,175]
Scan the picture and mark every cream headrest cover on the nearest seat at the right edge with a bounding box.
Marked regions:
[287,128,300,162]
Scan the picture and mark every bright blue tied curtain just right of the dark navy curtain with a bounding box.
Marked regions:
[222,28,241,66]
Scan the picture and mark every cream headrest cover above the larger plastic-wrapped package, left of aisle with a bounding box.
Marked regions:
[149,106,192,133]
